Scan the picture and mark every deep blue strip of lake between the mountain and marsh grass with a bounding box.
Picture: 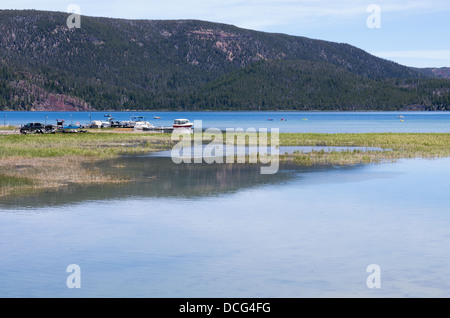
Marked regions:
[0,112,450,133]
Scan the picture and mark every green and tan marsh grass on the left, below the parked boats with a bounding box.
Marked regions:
[0,133,172,197]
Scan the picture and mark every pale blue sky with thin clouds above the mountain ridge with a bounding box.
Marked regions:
[0,0,450,67]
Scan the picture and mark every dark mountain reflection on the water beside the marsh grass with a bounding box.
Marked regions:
[0,156,304,208]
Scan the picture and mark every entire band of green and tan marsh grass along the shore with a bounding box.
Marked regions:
[0,129,450,198]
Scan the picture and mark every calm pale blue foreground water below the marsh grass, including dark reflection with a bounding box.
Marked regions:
[0,156,450,297]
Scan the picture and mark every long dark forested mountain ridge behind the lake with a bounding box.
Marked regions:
[0,10,450,110]
